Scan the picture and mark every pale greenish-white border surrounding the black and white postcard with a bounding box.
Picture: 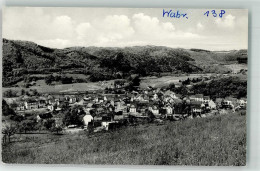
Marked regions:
[0,0,260,171]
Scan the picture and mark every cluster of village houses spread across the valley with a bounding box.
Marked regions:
[6,78,247,133]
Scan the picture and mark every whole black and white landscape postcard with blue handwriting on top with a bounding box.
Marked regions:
[1,7,248,166]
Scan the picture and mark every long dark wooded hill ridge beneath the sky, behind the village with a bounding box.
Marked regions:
[3,39,246,86]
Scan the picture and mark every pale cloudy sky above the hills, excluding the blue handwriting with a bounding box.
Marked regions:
[2,7,248,50]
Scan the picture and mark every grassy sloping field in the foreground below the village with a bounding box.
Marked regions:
[2,113,246,165]
